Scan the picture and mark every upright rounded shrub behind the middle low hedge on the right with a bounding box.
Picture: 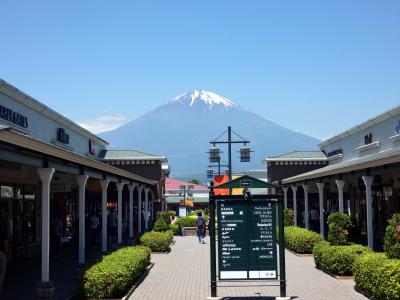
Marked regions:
[328,212,352,245]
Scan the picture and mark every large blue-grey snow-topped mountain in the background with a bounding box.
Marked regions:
[100,90,320,180]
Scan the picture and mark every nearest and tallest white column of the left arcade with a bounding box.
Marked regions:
[37,168,55,282]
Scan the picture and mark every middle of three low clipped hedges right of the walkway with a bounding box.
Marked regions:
[313,241,370,275]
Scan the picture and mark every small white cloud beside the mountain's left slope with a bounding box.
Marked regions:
[77,114,130,134]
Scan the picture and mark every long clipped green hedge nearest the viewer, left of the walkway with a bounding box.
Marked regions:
[82,246,150,299]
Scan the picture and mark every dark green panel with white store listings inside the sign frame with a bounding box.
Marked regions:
[217,199,277,280]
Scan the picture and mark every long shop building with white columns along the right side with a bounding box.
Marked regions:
[276,106,400,250]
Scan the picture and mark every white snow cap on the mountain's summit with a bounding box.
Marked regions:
[169,90,239,110]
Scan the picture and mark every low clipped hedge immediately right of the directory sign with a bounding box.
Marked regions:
[285,226,322,254]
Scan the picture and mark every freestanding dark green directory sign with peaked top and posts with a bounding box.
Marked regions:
[209,176,289,299]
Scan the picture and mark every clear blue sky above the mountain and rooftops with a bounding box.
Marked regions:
[0,0,400,138]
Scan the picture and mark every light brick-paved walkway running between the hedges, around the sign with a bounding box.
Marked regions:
[130,237,367,300]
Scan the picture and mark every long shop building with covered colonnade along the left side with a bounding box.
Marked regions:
[0,80,166,288]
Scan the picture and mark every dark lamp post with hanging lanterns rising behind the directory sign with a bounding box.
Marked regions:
[207,126,251,194]
